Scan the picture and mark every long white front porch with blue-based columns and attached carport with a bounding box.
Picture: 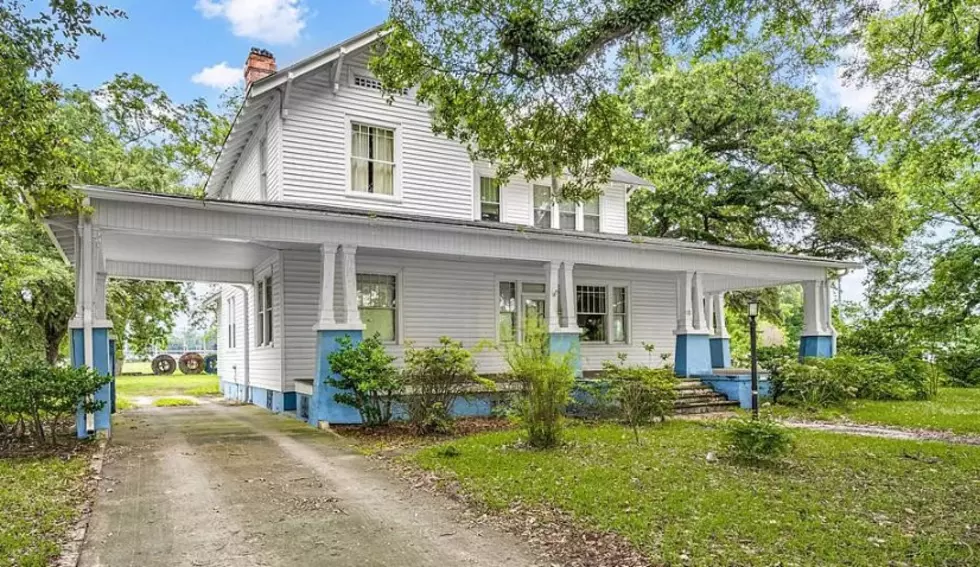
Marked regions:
[50,188,847,434]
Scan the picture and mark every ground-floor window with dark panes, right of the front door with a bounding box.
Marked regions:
[575,285,628,343]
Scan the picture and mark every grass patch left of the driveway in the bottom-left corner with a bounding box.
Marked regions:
[0,455,88,567]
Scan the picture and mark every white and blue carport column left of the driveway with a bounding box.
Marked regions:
[68,219,114,439]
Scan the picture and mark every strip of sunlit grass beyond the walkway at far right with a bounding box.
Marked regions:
[780,388,980,434]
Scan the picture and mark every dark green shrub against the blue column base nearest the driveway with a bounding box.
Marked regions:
[325,335,402,425]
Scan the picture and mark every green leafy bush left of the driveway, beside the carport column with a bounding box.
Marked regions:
[0,360,112,444]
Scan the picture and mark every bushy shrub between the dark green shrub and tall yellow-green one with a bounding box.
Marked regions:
[403,337,495,433]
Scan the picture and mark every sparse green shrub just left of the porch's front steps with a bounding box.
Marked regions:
[602,359,677,443]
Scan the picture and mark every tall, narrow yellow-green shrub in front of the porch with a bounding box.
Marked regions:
[504,317,575,449]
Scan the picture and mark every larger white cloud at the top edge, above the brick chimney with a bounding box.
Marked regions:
[196,0,308,44]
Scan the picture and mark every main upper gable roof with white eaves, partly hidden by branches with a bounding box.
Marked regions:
[204,24,653,197]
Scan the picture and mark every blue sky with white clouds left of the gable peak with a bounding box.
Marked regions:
[55,0,388,102]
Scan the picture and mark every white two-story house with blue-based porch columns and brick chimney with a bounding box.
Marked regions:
[51,22,849,430]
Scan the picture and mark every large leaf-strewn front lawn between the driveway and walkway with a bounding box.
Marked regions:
[412,421,980,565]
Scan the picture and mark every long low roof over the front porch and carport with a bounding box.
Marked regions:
[49,186,860,288]
